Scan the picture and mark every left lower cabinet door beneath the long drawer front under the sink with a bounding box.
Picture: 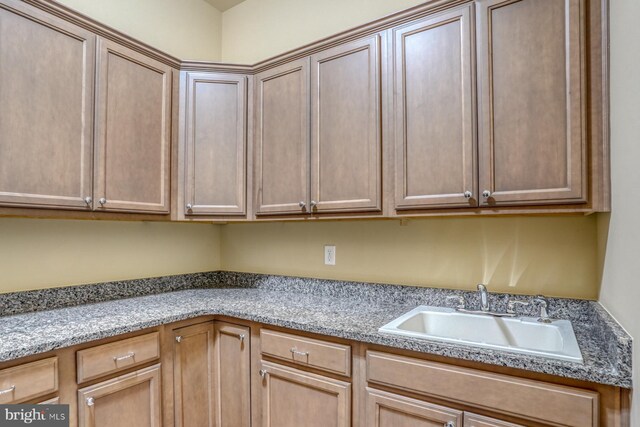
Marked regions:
[365,387,462,427]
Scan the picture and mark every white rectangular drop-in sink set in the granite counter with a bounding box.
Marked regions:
[379,306,583,363]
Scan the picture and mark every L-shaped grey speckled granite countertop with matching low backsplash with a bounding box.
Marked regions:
[0,272,632,388]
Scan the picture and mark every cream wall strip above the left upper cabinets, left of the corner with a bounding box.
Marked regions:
[58,0,222,61]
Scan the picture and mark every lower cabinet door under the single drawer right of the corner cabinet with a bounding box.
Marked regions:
[260,361,351,427]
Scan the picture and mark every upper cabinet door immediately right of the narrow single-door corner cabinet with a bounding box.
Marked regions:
[255,58,309,215]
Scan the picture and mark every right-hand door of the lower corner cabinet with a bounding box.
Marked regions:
[214,322,251,427]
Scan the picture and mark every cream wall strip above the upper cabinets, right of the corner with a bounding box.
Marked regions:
[222,0,424,63]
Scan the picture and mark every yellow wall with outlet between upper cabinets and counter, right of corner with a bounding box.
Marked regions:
[221,217,597,299]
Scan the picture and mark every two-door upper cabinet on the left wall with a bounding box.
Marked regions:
[0,0,173,214]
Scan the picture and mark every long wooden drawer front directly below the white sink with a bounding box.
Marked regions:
[366,351,599,427]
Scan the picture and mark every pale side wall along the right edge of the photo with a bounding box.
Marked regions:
[598,0,640,427]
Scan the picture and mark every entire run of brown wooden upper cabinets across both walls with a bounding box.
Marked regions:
[0,0,610,221]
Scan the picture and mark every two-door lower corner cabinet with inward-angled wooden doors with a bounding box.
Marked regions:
[173,321,251,427]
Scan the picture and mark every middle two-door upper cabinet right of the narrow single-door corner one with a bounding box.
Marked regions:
[255,34,382,215]
